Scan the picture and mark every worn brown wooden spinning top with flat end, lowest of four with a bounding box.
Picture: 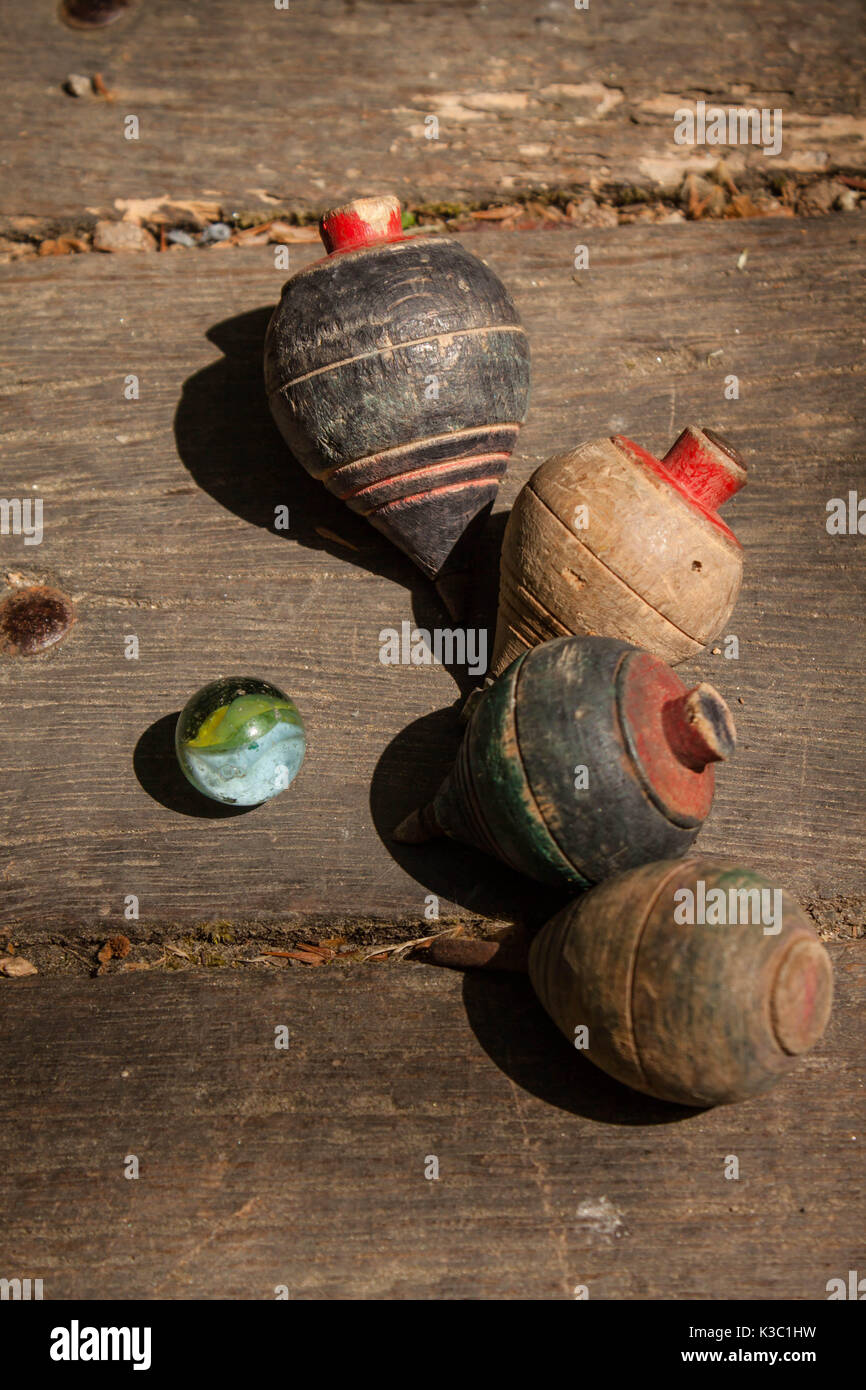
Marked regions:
[530,858,833,1105]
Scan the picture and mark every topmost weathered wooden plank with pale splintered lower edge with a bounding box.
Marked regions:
[0,0,866,218]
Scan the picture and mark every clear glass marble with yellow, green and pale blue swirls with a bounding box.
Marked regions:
[174,676,307,806]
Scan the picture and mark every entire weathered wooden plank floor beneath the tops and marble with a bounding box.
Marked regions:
[0,0,866,1300]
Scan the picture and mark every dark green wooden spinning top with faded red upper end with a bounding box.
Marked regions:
[393,637,735,888]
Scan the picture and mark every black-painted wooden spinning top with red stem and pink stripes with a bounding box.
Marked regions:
[264,197,530,616]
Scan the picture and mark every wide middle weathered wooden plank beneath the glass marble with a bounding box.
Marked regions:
[0,214,866,940]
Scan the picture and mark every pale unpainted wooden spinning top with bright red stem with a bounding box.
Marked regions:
[491,425,746,676]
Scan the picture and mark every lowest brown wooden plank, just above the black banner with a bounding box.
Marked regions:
[0,945,863,1300]
